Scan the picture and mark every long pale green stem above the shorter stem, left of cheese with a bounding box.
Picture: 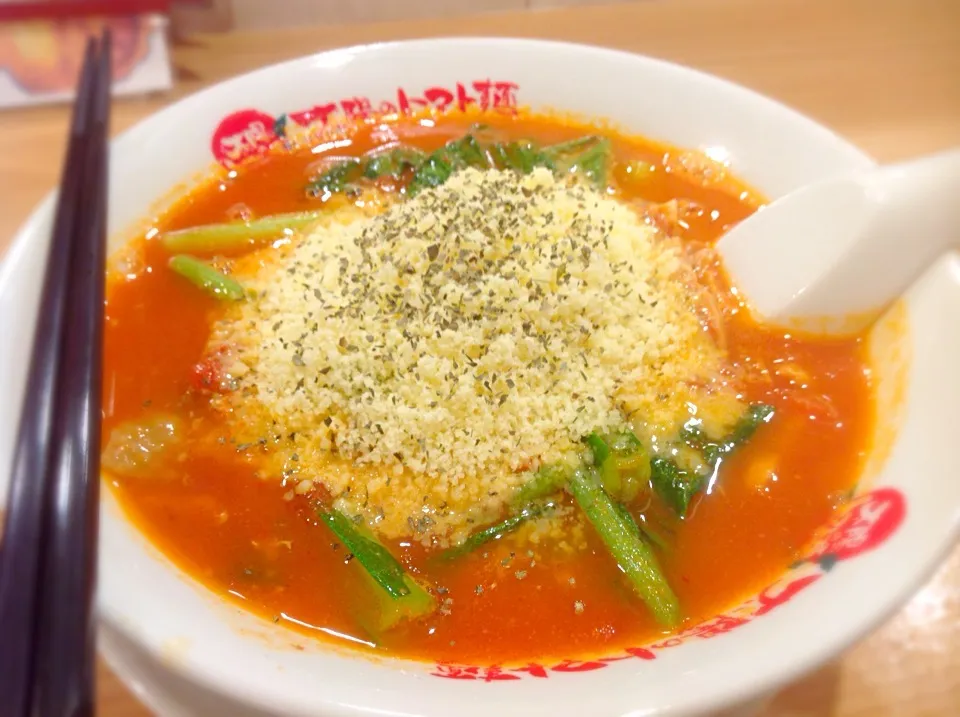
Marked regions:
[160,212,322,254]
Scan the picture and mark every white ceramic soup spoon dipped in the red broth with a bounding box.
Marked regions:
[717,149,960,330]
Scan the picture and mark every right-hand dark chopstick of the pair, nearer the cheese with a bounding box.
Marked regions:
[34,34,110,717]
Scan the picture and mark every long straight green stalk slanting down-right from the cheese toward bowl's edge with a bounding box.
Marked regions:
[570,467,680,626]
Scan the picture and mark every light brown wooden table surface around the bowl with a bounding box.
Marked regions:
[0,0,960,717]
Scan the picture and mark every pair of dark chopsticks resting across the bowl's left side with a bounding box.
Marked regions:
[0,32,111,717]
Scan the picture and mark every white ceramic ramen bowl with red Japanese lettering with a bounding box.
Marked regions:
[0,39,960,717]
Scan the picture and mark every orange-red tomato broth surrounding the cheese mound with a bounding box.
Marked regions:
[104,115,873,664]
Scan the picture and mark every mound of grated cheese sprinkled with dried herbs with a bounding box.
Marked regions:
[216,169,718,539]
